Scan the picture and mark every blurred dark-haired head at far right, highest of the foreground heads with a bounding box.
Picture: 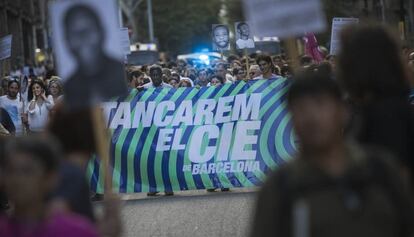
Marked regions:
[338,25,409,104]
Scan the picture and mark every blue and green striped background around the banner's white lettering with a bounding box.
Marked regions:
[87,79,296,193]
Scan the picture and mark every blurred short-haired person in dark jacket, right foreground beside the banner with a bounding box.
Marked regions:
[250,72,413,237]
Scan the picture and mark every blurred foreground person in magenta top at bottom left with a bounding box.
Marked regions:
[0,137,98,237]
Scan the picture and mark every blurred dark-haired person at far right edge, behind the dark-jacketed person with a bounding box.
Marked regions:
[337,25,414,184]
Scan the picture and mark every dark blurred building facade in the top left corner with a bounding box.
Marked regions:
[0,0,49,71]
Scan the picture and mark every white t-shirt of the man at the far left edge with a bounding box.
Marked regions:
[0,95,23,135]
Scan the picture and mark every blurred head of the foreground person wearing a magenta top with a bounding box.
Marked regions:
[4,136,62,209]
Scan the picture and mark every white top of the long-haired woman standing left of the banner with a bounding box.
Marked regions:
[26,95,54,132]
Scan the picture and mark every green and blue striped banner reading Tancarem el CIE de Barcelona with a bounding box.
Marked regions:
[88,79,296,193]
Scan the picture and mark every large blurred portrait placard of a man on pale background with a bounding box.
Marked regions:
[50,0,127,109]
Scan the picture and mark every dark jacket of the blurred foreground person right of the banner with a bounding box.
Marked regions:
[250,145,413,237]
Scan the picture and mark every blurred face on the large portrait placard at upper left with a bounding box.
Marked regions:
[66,8,104,63]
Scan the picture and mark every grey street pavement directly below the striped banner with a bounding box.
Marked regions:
[116,189,257,237]
